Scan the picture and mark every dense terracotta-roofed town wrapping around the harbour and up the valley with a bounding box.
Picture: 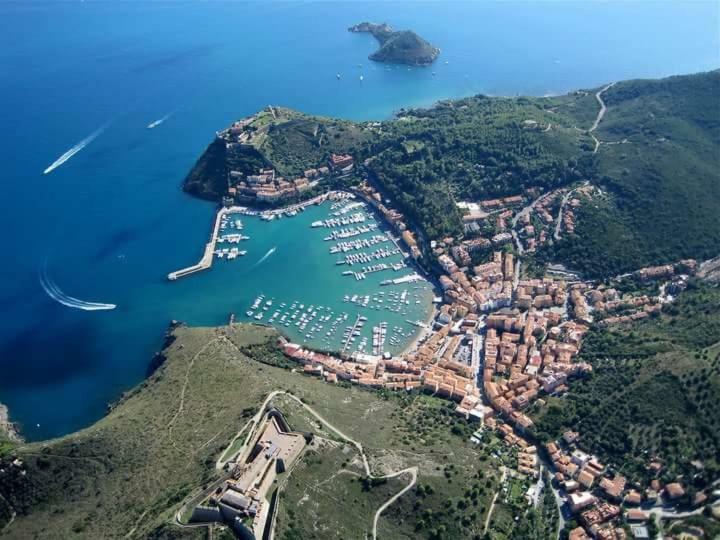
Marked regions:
[211,114,707,540]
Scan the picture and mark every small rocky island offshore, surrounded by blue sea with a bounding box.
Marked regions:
[348,22,440,66]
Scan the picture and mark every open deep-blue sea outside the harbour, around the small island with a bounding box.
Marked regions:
[0,1,720,439]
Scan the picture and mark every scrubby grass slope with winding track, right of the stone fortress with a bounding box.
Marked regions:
[278,388,498,538]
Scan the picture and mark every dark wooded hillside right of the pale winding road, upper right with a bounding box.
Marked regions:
[554,71,720,274]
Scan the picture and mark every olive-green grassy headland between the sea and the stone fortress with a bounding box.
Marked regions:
[0,329,282,538]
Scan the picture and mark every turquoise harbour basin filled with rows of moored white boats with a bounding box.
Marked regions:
[171,192,433,356]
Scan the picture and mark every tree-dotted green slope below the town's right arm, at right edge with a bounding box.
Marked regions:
[537,284,720,486]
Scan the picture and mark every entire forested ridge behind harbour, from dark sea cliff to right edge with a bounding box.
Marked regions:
[186,71,720,277]
